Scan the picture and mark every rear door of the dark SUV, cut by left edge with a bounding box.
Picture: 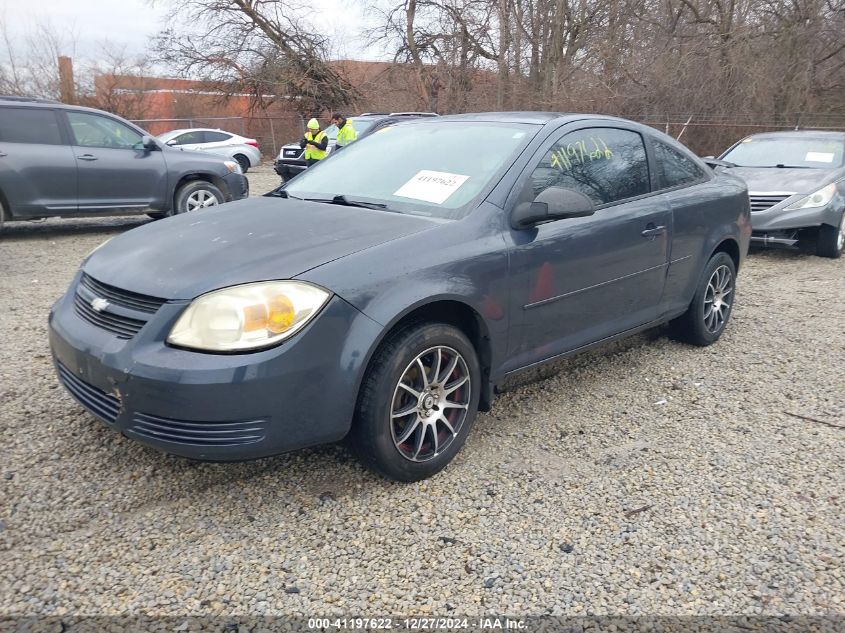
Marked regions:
[0,105,76,217]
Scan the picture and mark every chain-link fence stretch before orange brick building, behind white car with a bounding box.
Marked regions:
[133,114,305,158]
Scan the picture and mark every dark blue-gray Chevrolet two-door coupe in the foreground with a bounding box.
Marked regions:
[50,113,751,481]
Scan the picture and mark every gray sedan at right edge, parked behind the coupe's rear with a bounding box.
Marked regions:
[720,130,845,258]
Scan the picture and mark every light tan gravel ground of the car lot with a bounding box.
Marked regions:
[0,168,845,615]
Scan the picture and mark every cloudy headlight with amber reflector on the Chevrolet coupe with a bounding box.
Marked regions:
[167,281,331,352]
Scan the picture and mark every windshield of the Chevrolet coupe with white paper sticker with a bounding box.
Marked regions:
[285,121,537,218]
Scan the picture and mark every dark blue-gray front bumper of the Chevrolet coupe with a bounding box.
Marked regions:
[49,275,381,461]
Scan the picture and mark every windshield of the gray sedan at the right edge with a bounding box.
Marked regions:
[722,136,845,169]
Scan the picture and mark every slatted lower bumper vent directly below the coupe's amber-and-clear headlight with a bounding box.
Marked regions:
[129,413,267,446]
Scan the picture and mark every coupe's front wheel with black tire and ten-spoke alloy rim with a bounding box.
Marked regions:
[349,323,481,482]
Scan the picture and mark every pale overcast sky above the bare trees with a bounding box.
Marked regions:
[0,0,384,60]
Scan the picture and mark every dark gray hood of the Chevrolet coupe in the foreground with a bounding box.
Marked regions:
[83,198,437,300]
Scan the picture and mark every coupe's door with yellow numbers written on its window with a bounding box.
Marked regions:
[506,124,672,370]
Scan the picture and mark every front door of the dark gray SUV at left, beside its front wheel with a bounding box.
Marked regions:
[66,111,168,213]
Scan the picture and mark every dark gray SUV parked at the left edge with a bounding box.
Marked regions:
[0,97,249,228]
